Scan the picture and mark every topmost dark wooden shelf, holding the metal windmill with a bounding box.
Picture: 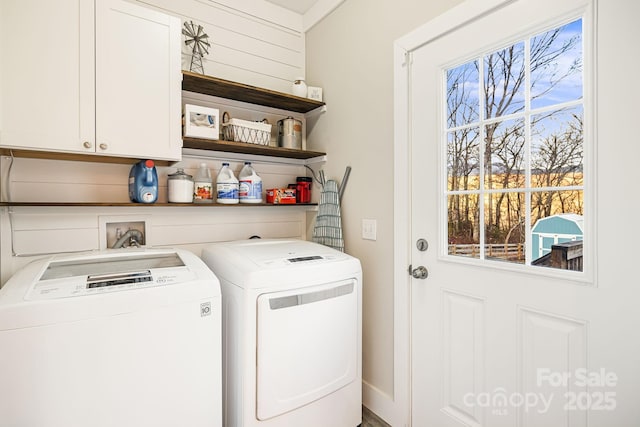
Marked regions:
[182,71,325,113]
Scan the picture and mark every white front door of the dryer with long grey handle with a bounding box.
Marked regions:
[256,280,359,420]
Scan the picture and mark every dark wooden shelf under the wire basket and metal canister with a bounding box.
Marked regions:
[182,137,326,159]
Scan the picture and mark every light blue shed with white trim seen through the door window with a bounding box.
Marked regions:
[531,213,584,260]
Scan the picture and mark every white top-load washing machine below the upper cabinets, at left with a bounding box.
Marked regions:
[0,249,222,427]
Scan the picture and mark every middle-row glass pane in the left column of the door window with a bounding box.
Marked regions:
[447,127,480,191]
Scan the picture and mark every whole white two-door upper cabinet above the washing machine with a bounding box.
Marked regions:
[0,0,182,160]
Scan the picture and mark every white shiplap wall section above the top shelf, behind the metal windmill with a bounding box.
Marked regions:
[137,0,305,93]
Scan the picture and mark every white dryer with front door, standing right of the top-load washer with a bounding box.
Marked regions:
[202,239,362,427]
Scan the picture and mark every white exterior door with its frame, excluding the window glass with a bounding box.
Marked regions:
[396,0,640,427]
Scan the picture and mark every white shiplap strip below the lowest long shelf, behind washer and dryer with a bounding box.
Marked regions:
[0,206,306,284]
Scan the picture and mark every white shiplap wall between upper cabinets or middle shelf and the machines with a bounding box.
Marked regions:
[0,153,318,284]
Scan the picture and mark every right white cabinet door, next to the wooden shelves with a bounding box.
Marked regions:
[96,0,182,160]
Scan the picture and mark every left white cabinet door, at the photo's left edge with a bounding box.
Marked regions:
[0,0,95,152]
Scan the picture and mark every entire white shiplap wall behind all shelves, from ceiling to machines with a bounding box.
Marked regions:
[0,0,318,285]
